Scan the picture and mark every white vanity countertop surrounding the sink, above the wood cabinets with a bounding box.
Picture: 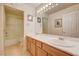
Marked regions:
[26,34,79,56]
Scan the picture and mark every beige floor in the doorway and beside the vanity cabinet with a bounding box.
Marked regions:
[5,43,30,56]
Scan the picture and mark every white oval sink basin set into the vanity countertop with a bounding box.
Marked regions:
[51,39,75,47]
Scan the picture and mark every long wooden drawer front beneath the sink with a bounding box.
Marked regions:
[42,44,70,56]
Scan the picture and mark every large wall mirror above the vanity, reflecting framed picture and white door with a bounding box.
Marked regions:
[37,3,79,37]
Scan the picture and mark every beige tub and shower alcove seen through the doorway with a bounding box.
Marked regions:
[5,13,23,46]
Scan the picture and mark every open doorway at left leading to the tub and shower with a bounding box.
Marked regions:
[4,6,24,56]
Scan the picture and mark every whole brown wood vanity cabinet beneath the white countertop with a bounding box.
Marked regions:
[27,36,72,56]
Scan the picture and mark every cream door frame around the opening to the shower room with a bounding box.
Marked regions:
[3,5,24,56]
